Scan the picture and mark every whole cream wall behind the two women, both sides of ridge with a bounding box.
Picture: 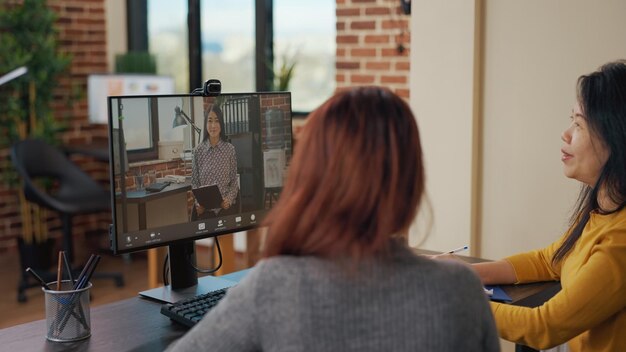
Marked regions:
[411,0,626,259]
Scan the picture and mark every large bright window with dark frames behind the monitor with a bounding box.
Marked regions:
[135,0,336,161]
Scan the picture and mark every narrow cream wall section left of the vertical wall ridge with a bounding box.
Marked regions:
[409,0,474,250]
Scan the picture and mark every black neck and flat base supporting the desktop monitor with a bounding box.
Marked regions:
[139,241,237,303]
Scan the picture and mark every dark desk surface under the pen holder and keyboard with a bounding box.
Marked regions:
[0,254,560,352]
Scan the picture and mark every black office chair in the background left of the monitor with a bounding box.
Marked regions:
[11,139,124,302]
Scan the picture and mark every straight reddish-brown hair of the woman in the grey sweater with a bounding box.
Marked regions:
[264,87,424,259]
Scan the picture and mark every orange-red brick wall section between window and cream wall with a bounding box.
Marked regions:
[336,0,410,99]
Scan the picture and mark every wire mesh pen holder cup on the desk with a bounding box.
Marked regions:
[43,280,91,342]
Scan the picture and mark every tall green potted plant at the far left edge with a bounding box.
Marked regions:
[0,0,76,243]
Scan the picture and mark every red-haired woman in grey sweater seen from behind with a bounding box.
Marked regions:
[166,87,500,352]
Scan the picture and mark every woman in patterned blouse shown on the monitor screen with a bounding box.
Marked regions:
[191,104,239,220]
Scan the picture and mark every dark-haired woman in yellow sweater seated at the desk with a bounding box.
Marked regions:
[473,61,626,351]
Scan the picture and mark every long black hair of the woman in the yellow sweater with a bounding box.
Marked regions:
[552,60,626,264]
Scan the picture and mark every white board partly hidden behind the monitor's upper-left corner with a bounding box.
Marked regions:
[87,74,174,124]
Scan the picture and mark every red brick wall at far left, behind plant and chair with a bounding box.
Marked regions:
[0,0,111,252]
